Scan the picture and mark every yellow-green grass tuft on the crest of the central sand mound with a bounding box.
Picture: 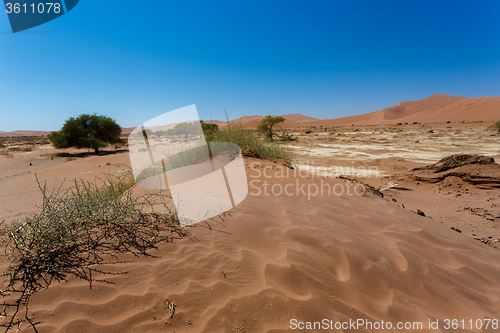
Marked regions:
[211,124,293,164]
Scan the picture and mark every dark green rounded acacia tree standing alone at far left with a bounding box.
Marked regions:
[48,114,122,154]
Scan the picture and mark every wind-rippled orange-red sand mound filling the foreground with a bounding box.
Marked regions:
[1,155,500,333]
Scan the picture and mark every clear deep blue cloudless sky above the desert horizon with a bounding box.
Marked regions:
[0,0,500,131]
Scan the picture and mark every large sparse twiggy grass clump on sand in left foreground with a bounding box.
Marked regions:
[0,175,189,331]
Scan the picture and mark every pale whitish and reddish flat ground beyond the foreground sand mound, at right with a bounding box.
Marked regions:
[287,124,500,248]
